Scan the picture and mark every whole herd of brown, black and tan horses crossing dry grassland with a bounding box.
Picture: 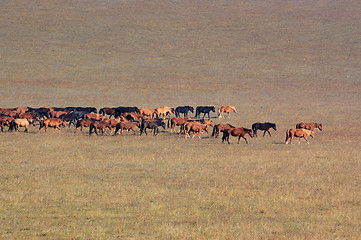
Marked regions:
[0,106,322,144]
